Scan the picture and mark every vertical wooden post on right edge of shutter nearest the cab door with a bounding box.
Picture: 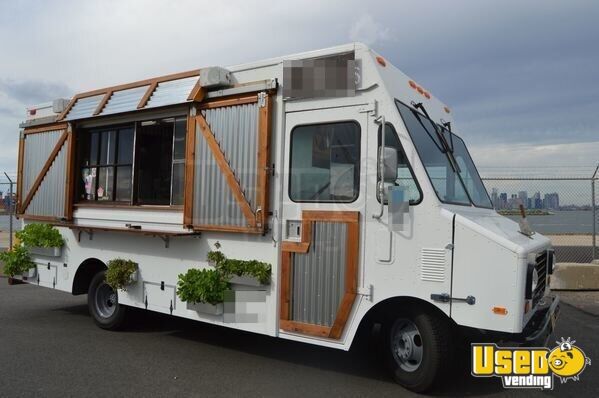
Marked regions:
[256,95,272,228]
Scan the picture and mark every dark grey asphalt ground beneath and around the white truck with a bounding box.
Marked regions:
[0,278,599,397]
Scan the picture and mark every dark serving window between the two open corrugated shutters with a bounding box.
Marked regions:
[77,118,187,205]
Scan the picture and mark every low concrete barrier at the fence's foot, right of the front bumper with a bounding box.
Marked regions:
[549,263,599,290]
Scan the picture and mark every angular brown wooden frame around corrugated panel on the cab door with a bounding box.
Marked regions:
[279,210,360,340]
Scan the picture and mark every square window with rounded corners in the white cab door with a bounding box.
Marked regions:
[289,122,360,202]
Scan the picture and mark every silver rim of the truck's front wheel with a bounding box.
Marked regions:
[391,319,423,372]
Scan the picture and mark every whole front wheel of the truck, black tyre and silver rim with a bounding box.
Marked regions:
[383,309,452,392]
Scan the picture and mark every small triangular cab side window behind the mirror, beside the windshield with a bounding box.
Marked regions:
[377,123,422,205]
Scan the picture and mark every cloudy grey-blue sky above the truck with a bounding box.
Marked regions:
[0,0,599,174]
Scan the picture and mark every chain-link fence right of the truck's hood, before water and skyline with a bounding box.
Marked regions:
[483,167,599,264]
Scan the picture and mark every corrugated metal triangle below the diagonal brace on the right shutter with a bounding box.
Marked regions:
[193,116,247,227]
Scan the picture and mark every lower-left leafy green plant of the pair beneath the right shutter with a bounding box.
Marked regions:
[177,268,229,305]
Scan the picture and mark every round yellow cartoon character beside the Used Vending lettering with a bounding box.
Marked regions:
[548,337,591,383]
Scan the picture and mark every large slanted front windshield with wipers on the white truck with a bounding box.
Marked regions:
[396,100,492,208]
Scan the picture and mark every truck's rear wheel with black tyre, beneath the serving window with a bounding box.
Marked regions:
[87,271,127,330]
